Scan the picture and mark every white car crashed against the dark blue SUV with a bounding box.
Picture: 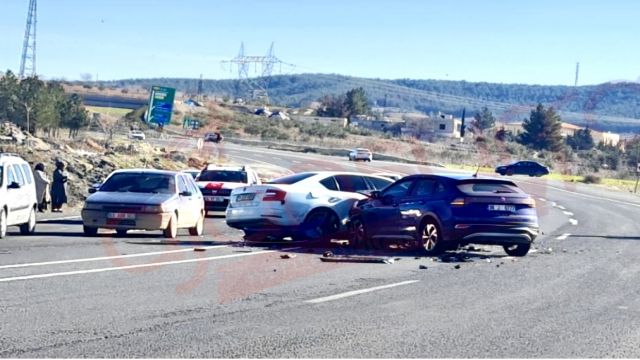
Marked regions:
[226,171,393,242]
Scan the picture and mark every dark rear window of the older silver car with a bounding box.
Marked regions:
[100,173,176,194]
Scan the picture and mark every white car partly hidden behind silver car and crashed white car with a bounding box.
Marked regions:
[197,164,262,215]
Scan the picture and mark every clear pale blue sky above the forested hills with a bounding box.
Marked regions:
[0,0,640,85]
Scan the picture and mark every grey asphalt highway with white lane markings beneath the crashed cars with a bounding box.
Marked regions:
[0,140,640,358]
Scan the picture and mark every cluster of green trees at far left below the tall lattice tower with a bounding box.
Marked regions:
[0,71,89,137]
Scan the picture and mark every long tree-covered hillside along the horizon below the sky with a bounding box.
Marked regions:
[104,74,640,132]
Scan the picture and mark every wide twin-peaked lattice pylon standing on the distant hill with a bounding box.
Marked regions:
[222,43,294,104]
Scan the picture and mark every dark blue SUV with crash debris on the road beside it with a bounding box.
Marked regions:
[350,174,539,256]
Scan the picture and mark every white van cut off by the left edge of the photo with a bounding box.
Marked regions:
[0,153,38,239]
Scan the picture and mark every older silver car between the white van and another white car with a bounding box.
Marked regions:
[81,169,205,238]
